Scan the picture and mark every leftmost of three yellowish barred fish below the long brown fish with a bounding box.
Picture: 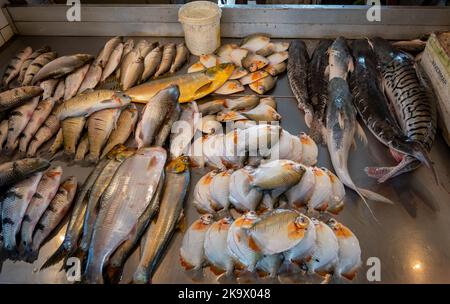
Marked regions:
[61,116,86,158]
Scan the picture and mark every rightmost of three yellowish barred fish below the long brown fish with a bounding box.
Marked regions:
[101,104,139,158]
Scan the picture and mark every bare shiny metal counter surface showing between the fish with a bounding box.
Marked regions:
[0,36,450,283]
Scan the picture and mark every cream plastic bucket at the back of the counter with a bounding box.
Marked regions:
[178,1,222,56]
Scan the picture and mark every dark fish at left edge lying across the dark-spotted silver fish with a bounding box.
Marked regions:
[0,158,50,188]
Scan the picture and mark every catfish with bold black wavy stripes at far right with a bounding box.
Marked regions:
[366,38,438,182]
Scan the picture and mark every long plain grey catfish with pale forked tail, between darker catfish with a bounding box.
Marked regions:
[326,37,391,212]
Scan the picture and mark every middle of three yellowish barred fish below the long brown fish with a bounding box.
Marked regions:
[86,108,121,163]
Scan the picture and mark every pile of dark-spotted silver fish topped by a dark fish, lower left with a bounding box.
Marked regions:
[0,159,77,262]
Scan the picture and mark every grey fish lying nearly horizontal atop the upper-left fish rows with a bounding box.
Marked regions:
[31,54,94,84]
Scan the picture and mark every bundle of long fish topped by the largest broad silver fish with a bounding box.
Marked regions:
[42,145,190,283]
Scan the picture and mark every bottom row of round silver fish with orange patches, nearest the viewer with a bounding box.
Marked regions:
[180,209,361,281]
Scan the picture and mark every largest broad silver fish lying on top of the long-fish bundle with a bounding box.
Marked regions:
[85,148,167,283]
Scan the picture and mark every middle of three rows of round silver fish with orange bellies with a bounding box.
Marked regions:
[193,159,345,214]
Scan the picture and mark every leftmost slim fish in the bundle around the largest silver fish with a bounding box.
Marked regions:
[41,147,130,269]
